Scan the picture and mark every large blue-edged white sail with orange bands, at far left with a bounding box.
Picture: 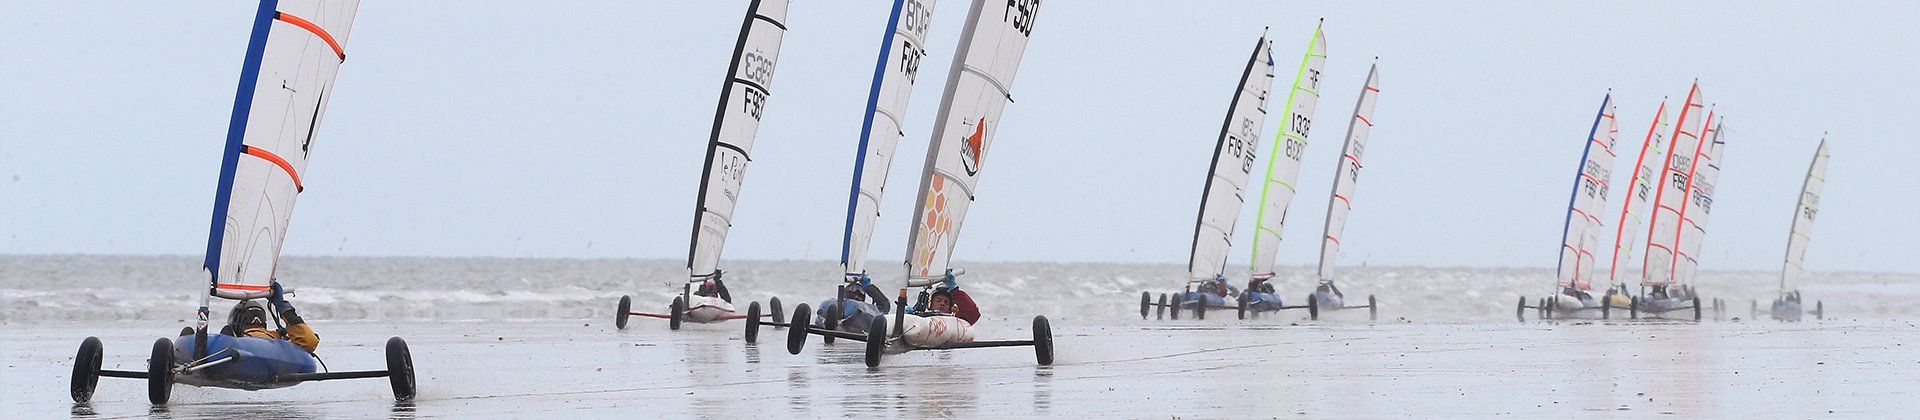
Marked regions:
[202,0,359,299]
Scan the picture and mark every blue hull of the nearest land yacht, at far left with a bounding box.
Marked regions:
[173,334,319,389]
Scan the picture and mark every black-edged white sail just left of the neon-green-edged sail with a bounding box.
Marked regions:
[1187,33,1273,280]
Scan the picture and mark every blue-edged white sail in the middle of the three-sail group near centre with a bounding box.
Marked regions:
[841,0,935,276]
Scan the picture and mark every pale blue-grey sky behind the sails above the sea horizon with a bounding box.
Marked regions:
[0,0,1920,272]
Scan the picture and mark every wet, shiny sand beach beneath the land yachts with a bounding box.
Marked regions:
[0,315,1920,418]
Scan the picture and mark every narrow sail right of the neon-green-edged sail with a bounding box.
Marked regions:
[1319,65,1380,282]
